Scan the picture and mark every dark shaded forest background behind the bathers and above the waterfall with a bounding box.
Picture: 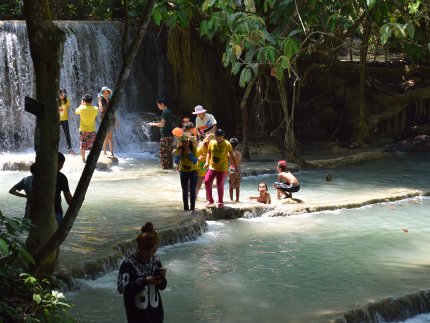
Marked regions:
[0,1,430,160]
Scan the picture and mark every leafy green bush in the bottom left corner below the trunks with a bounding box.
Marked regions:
[0,212,75,322]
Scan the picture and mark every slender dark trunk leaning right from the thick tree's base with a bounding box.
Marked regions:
[32,0,155,274]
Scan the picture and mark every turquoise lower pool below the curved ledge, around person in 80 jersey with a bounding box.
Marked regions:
[68,198,430,322]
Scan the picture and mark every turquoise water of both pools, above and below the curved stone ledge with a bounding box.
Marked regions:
[0,154,430,322]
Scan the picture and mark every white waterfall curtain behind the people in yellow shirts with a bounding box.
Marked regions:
[0,21,159,152]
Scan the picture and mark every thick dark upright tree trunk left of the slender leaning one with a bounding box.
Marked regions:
[24,0,65,275]
